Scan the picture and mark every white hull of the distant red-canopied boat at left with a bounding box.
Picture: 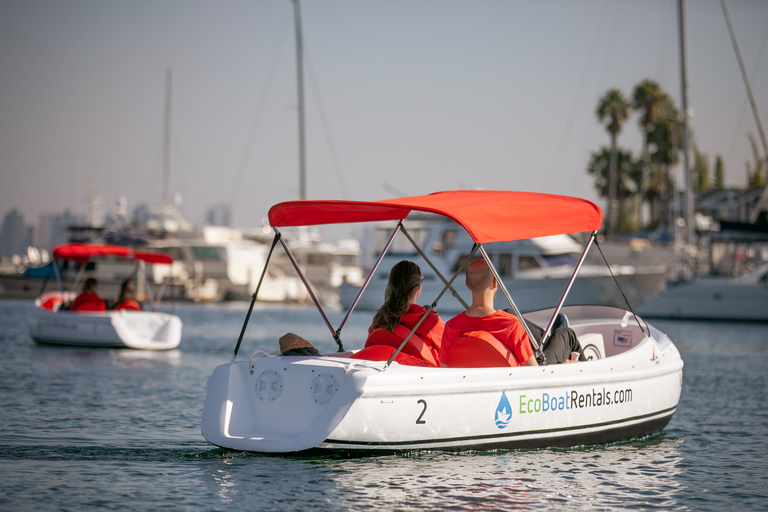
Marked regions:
[27,307,182,350]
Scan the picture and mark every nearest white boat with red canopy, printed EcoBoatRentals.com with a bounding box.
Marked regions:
[202,191,683,453]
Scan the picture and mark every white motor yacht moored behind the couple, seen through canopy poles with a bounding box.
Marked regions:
[339,218,669,314]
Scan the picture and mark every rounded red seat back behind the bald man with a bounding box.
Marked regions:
[445,331,520,368]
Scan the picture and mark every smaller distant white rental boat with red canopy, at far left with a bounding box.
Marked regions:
[27,244,182,350]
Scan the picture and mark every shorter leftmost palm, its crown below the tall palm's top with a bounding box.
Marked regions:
[587,146,642,233]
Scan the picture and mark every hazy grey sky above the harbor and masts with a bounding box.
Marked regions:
[0,0,768,232]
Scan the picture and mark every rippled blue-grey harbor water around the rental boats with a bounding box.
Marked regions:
[0,300,768,512]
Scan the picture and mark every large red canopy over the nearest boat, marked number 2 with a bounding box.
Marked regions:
[269,190,603,243]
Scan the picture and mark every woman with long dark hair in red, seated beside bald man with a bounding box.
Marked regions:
[352,260,444,367]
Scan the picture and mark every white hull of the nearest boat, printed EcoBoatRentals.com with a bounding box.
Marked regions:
[202,307,683,453]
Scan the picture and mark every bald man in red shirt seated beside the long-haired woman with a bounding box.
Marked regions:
[440,260,586,366]
